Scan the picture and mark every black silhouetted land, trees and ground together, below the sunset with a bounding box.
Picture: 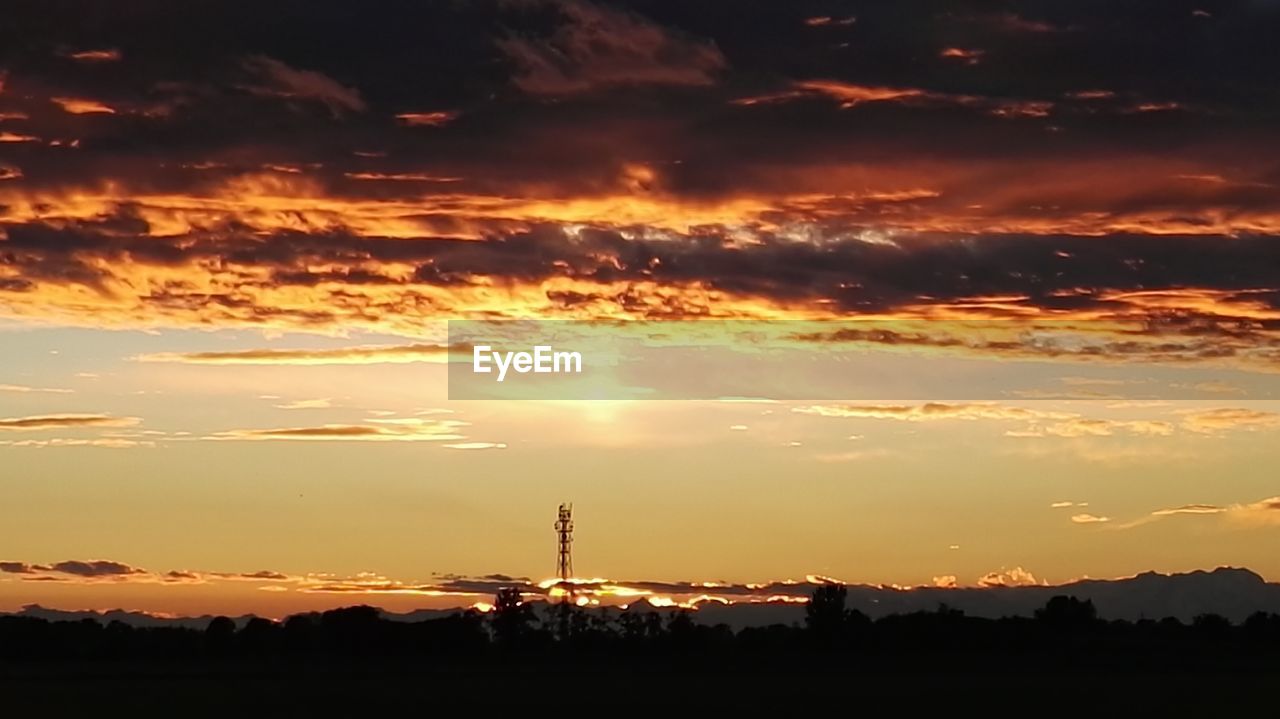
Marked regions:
[0,569,1280,713]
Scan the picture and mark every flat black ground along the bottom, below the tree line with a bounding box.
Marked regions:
[0,656,1280,716]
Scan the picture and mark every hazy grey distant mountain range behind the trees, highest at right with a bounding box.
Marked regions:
[5,567,1280,629]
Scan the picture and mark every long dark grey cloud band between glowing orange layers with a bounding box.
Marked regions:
[15,218,1280,313]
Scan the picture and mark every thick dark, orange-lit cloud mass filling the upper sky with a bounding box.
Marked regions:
[0,0,1280,330]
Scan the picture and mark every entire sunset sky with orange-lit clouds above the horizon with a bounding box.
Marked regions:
[0,0,1280,617]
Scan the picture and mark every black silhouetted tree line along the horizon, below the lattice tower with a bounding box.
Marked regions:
[0,585,1280,664]
